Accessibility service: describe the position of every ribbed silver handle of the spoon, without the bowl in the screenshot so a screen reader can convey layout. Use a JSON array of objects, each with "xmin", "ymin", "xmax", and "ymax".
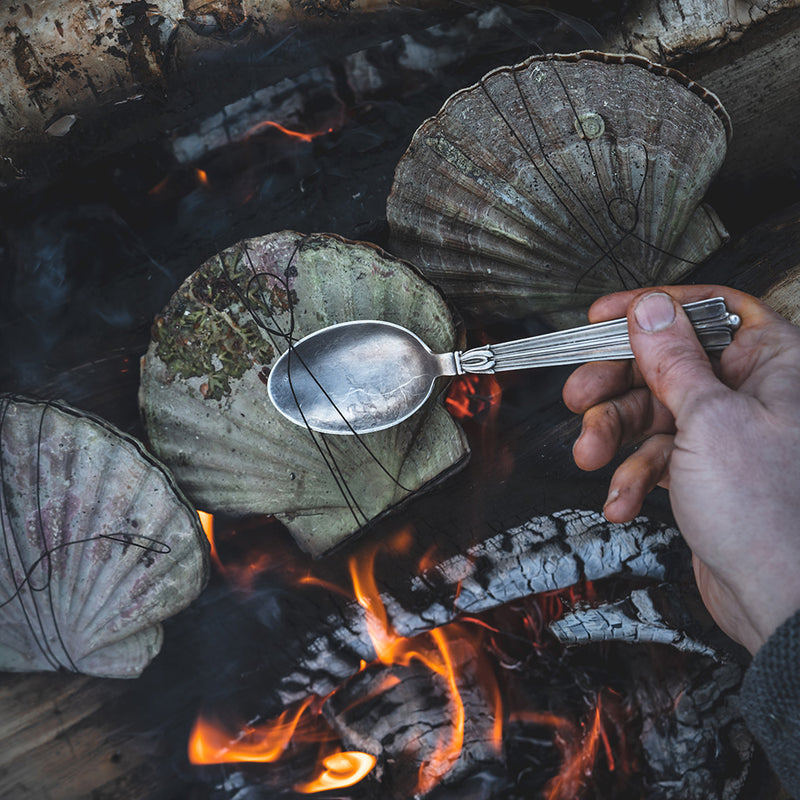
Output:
[{"xmin": 455, "ymin": 297, "xmax": 741, "ymax": 375}]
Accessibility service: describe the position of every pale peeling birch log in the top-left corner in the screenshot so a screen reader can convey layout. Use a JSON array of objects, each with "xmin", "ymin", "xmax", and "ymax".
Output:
[{"xmin": 0, "ymin": 0, "xmax": 454, "ymax": 171}]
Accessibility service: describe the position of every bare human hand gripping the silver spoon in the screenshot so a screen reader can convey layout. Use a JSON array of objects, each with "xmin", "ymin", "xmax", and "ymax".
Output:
[{"xmin": 563, "ymin": 286, "xmax": 800, "ymax": 653}]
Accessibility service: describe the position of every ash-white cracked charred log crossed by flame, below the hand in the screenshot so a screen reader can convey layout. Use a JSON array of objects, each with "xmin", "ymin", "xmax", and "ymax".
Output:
[{"xmin": 272, "ymin": 511, "xmax": 708, "ymax": 705}]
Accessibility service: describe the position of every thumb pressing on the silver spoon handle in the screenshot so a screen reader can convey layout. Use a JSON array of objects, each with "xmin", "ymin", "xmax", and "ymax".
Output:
[{"xmin": 628, "ymin": 292, "xmax": 726, "ymax": 420}]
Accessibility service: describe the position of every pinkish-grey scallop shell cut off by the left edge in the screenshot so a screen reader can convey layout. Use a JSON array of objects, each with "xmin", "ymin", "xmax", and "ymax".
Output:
[{"xmin": 0, "ymin": 395, "xmax": 209, "ymax": 678}]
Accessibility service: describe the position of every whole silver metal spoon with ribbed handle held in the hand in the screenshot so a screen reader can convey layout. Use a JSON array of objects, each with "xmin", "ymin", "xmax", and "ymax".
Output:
[{"xmin": 267, "ymin": 297, "xmax": 740, "ymax": 434}]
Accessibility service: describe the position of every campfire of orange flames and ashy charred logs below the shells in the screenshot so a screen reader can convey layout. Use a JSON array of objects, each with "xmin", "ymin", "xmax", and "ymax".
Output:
[{"xmin": 178, "ymin": 500, "xmax": 750, "ymax": 800}]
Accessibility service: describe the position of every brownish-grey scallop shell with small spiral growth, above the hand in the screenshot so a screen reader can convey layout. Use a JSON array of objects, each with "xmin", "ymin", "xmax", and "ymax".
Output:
[{"xmin": 387, "ymin": 51, "xmax": 730, "ymax": 316}]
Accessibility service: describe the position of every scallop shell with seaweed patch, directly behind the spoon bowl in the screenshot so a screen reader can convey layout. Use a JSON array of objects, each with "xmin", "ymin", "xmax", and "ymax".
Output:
[{"xmin": 139, "ymin": 232, "xmax": 468, "ymax": 555}]
